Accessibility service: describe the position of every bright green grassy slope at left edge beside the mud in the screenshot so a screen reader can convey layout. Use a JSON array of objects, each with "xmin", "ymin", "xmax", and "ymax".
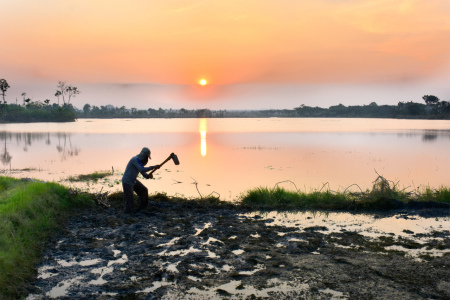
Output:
[{"xmin": 0, "ymin": 177, "xmax": 93, "ymax": 299}]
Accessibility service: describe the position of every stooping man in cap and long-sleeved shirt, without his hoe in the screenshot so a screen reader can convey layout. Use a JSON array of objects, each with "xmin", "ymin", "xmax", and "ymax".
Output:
[{"xmin": 122, "ymin": 147, "xmax": 160, "ymax": 214}]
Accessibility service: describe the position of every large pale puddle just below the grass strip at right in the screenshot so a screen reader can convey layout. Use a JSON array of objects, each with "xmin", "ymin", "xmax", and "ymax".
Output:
[{"xmin": 246, "ymin": 212, "xmax": 450, "ymax": 258}]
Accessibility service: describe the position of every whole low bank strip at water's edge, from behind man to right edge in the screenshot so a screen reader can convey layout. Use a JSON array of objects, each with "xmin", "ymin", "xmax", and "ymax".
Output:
[{"xmin": 103, "ymin": 172, "xmax": 450, "ymax": 212}]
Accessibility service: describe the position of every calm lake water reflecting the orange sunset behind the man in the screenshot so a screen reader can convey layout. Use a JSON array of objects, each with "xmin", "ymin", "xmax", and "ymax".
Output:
[{"xmin": 0, "ymin": 118, "xmax": 450, "ymax": 200}]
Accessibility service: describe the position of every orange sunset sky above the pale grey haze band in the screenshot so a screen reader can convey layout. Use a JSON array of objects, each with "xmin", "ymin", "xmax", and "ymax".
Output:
[{"xmin": 0, "ymin": 0, "xmax": 450, "ymax": 108}]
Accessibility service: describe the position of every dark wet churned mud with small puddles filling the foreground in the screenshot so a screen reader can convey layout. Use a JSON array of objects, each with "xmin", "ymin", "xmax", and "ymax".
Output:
[{"xmin": 28, "ymin": 202, "xmax": 450, "ymax": 299}]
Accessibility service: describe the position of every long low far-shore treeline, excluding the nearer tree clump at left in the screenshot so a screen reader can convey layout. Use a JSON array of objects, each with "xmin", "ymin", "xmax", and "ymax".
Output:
[{"xmin": 77, "ymin": 95, "xmax": 450, "ymax": 119}]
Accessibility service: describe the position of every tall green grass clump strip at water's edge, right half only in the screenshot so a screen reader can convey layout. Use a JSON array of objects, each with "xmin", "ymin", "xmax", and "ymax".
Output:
[{"xmin": 241, "ymin": 176, "xmax": 450, "ymax": 210}]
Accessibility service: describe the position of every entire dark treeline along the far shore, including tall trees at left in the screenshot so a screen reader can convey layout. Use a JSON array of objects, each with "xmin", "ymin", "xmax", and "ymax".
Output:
[{"xmin": 0, "ymin": 79, "xmax": 450, "ymax": 123}]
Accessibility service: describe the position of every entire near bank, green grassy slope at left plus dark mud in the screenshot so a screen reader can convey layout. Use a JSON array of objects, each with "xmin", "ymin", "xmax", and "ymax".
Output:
[{"xmin": 0, "ymin": 177, "xmax": 450, "ymax": 299}]
